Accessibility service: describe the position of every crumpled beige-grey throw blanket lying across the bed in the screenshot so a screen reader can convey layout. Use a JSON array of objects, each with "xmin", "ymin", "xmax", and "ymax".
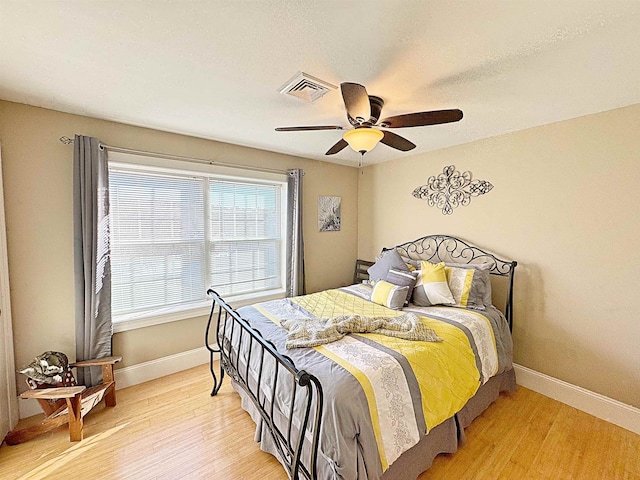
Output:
[{"xmin": 281, "ymin": 313, "xmax": 442, "ymax": 348}]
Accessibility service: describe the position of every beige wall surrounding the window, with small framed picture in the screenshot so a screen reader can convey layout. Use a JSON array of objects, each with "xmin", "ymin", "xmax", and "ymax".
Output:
[{"xmin": 0, "ymin": 101, "xmax": 358, "ymax": 372}]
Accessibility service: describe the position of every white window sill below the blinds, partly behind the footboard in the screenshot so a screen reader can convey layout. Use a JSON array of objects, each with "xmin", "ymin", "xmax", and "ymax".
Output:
[{"xmin": 113, "ymin": 290, "xmax": 285, "ymax": 333}]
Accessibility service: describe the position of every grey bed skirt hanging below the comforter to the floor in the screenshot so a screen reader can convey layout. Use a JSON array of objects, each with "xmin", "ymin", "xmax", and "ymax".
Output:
[{"xmin": 232, "ymin": 369, "xmax": 516, "ymax": 480}]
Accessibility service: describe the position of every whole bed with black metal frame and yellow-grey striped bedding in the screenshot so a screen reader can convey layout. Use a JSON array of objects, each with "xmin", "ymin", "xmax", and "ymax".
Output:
[{"xmin": 205, "ymin": 235, "xmax": 516, "ymax": 480}]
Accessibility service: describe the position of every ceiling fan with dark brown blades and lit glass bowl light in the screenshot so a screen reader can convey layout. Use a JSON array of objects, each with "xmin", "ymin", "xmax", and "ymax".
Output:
[{"xmin": 276, "ymin": 82, "xmax": 462, "ymax": 159}]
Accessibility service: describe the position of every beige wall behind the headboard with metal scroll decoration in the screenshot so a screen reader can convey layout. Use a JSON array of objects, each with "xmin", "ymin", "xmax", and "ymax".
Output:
[{"xmin": 358, "ymin": 105, "xmax": 640, "ymax": 407}]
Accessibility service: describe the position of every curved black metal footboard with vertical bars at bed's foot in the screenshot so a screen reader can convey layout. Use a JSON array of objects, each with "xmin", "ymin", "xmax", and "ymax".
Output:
[{"xmin": 205, "ymin": 289, "xmax": 323, "ymax": 480}]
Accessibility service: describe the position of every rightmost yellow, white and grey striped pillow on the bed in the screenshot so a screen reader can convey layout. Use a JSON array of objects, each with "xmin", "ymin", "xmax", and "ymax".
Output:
[{"xmin": 445, "ymin": 264, "xmax": 490, "ymax": 310}]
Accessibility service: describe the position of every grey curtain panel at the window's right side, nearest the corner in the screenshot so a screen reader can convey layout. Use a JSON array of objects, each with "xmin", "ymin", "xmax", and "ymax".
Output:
[{"xmin": 287, "ymin": 168, "xmax": 306, "ymax": 297}]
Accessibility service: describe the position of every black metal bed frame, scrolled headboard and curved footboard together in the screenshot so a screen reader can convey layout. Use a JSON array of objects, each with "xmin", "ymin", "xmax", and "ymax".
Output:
[{"xmin": 205, "ymin": 235, "xmax": 517, "ymax": 480}]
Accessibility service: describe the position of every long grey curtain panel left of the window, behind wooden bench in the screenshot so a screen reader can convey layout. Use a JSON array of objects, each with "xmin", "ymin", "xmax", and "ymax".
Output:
[{"xmin": 73, "ymin": 135, "xmax": 113, "ymax": 386}]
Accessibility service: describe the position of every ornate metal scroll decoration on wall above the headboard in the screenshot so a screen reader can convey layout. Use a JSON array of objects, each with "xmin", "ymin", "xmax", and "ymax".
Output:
[{"xmin": 413, "ymin": 165, "xmax": 493, "ymax": 215}]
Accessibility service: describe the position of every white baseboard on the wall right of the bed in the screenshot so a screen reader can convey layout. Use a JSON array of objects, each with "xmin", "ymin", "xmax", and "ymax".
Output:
[{"xmin": 513, "ymin": 364, "xmax": 640, "ymax": 435}]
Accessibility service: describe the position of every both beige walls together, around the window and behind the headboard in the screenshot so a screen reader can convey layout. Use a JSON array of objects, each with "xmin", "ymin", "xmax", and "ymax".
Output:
[{"xmin": 0, "ymin": 97, "xmax": 640, "ymax": 407}]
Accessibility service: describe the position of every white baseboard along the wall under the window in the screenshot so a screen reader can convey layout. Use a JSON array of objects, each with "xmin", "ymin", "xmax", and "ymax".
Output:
[{"xmin": 18, "ymin": 347, "xmax": 216, "ymax": 418}]
